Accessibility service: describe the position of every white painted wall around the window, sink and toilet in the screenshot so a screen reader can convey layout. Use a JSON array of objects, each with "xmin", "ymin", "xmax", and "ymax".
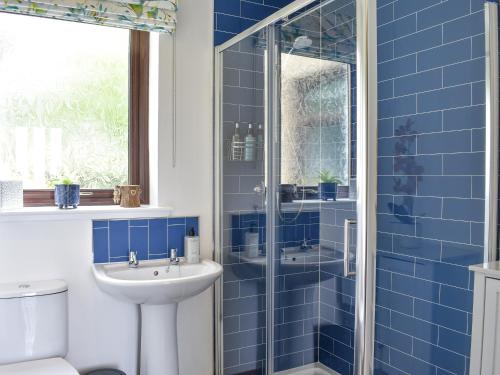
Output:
[{"xmin": 0, "ymin": 0, "xmax": 213, "ymax": 375}]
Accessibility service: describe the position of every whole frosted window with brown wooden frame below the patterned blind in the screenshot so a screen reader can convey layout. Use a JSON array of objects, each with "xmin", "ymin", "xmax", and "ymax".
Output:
[{"xmin": 0, "ymin": 13, "xmax": 149, "ymax": 206}]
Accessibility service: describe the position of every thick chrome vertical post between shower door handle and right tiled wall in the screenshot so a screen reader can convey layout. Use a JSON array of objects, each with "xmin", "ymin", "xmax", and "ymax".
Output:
[{"xmin": 354, "ymin": 0, "xmax": 377, "ymax": 375}]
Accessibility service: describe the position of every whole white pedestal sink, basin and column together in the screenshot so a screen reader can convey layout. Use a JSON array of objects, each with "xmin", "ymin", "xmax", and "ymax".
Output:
[{"xmin": 93, "ymin": 260, "xmax": 222, "ymax": 375}]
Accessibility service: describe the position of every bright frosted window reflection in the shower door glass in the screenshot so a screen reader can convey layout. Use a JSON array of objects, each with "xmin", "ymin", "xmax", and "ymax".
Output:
[{"xmin": 281, "ymin": 54, "xmax": 350, "ymax": 186}]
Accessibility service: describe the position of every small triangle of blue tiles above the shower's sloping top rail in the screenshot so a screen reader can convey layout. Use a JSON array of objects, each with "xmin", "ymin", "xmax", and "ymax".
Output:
[{"xmin": 214, "ymin": 0, "xmax": 293, "ymax": 45}]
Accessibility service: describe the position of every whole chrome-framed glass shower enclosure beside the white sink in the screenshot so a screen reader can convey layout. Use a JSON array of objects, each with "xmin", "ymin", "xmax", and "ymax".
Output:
[{"xmin": 215, "ymin": 0, "xmax": 377, "ymax": 375}]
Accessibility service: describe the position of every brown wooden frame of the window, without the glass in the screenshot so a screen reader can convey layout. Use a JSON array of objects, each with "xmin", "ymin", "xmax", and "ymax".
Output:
[{"xmin": 23, "ymin": 30, "xmax": 149, "ymax": 207}]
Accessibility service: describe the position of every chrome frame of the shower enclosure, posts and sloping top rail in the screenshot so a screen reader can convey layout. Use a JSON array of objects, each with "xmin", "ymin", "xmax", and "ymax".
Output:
[{"xmin": 213, "ymin": 0, "xmax": 378, "ymax": 375}]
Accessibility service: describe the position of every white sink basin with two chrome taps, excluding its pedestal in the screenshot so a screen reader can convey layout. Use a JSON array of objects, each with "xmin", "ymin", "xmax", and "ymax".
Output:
[{"xmin": 94, "ymin": 259, "xmax": 222, "ymax": 305}]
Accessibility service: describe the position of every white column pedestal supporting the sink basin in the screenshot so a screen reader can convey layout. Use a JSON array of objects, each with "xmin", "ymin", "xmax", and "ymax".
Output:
[{"xmin": 140, "ymin": 303, "xmax": 179, "ymax": 375}]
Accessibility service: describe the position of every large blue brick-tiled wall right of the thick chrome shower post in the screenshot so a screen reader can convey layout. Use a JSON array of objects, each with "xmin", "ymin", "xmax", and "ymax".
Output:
[{"xmin": 375, "ymin": 0, "xmax": 485, "ymax": 374}]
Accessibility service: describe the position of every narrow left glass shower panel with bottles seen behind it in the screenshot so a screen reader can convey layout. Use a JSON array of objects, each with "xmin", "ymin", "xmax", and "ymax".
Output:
[{"xmin": 219, "ymin": 30, "xmax": 268, "ymax": 375}]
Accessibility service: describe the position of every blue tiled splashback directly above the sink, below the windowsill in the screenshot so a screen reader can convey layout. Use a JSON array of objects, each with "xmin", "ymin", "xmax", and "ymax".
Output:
[{"xmin": 92, "ymin": 217, "xmax": 199, "ymax": 263}]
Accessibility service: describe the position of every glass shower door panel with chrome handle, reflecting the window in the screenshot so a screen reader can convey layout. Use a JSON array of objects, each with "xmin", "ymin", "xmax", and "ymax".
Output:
[{"xmin": 274, "ymin": 0, "xmax": 357, "ymax": 375}]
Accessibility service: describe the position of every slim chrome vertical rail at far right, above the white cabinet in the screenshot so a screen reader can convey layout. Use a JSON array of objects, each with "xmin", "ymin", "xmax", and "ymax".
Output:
[{"xmin": 484, "ymin": 2, "xmax": 499, "ymax": 262}]
